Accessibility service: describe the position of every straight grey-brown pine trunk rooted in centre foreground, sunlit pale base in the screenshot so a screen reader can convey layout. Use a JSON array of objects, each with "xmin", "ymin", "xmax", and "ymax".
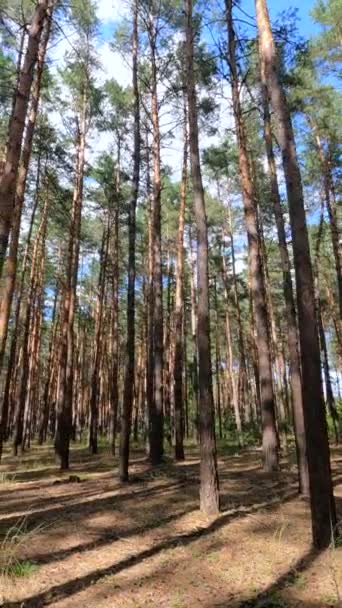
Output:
[{"xmin": 184, "ymin": 0, "xmax": 219, "ymax": 515}]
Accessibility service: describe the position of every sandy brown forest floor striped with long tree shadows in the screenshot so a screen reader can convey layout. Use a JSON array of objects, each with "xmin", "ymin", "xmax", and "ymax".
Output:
[{"xmin": 0, "ymin": 447, "xmax": 342, "ymax": 608}]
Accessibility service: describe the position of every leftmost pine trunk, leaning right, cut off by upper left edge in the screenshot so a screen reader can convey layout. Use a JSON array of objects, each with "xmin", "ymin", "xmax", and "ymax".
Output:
[{"xmin": 0, "ymin": 0, "xmax": 52, "ymax": 277}]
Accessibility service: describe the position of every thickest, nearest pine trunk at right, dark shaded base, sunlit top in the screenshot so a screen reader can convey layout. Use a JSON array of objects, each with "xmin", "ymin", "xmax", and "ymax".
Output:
[{"xmin": 255, "ymin": 0, "xmax": 337, "ymax": 548}]
